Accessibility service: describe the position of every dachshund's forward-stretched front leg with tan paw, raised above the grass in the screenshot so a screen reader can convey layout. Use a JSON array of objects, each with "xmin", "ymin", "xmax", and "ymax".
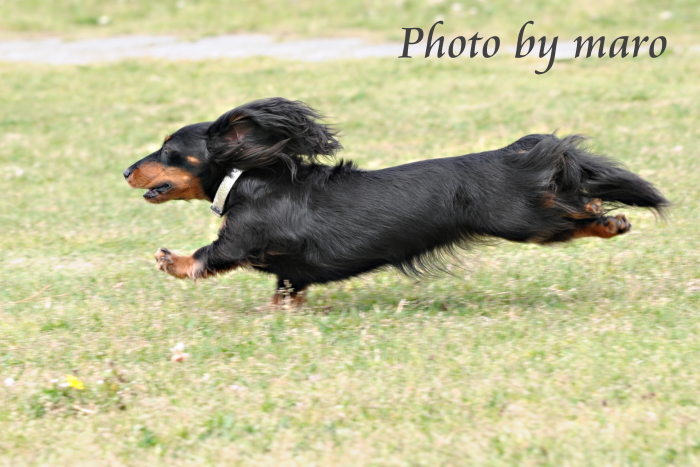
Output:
[{"xmin": 155, "ymin": 245, "xmax": 241, "ymax": 280}]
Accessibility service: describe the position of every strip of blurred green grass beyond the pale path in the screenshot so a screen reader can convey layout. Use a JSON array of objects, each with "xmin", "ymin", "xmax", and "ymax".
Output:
[{"xmin": 0, "ymin": 0, "xmax": 700, "ymax": 45}]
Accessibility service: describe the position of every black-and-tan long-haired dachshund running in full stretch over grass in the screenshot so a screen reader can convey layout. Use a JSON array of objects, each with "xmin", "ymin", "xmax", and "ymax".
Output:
[{"xmin": 124, "ymin": 97, "xmax": 668, "ymax": 304}]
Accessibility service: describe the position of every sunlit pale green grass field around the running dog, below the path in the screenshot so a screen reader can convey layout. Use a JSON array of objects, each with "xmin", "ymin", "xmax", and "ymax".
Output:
[{"xmin": 0, "ymin": 4, "xmax": 700, "ymax": 466}]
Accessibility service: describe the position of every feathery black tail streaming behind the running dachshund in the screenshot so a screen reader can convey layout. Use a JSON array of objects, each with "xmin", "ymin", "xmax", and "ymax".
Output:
[{"xmin": 511, "ymin": 135, "xmax": 670, "ymax": 215}]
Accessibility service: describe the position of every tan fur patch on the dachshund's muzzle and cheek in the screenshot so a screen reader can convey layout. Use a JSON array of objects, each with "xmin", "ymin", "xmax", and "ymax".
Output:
[{"xmin": 126, "ymin": 162, "xmax": 211, "ymax": 204}]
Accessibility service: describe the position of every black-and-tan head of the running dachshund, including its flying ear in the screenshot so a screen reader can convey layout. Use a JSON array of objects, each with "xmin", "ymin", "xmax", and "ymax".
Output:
[{"xmin": 124, "ymin": 97, "xmax": 341, "ymax": 203}]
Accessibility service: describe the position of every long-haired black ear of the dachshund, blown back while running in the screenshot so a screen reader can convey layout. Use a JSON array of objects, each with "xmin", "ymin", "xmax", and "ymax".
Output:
[{"xmin": 207, "ymin": 97, "xmax": 342, "ymax": 170}]
